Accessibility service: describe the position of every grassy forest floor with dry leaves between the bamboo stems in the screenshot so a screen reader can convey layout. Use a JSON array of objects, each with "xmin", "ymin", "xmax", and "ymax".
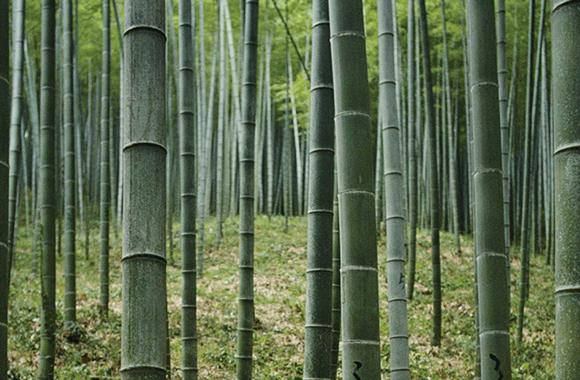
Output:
[{"xmin": 9, "ymin": 217, "xmax": 554, "ymax": 380}]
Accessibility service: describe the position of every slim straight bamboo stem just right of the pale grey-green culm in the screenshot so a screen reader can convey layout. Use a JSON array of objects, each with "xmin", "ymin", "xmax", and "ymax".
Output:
[{"xmin": 407, "ymin": 0, "xmax": 418, "ymax": 300}]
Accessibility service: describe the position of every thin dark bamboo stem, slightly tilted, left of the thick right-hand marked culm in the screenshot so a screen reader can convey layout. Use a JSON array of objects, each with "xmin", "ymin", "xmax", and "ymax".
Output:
[{"xmin": 419, "ymin": 0, "xmax": 441, "ymax": 346}]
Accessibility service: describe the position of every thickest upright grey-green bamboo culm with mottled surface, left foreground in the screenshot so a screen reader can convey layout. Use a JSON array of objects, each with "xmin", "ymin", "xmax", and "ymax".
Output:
[{"xmin": 121, "ymin": 0, "xmax": 167, "ymax": 380}]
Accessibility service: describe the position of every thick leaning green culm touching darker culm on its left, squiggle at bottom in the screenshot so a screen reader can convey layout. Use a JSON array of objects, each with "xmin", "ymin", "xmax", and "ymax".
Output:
[{"xmin": 329, "ymin": 0, "xmax": 380, "ymax": 380}]
